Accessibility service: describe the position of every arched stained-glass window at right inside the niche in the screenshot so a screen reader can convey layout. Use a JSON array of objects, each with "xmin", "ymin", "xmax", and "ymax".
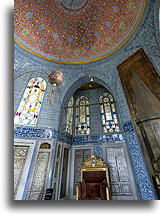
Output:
[{"xmin": 99, "ymin": 93, "xmax": 119, "ymax": 133}]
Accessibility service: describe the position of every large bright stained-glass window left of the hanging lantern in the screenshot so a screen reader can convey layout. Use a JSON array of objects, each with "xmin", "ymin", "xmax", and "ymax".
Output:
[{"xmin": 14, "ymin": 77, "xmax": 46, "ymax": 125}]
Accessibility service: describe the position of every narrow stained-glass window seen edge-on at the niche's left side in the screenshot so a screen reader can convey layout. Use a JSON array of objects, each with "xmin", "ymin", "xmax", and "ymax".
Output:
[{"xmin": 66, "ymin": 97, "xmax": 74, "ymax": 134}]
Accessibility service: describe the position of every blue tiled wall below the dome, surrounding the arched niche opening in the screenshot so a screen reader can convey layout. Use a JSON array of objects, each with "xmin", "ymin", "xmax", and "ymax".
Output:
[{"xmin": 14, "ymin": 0, "xmax": 160, "ymax": 200}]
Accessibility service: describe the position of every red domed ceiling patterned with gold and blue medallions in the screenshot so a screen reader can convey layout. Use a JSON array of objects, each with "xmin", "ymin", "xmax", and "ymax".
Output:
[{"xmin": 14, "ymin": 0, "xmax": 146, "ymax": 64}]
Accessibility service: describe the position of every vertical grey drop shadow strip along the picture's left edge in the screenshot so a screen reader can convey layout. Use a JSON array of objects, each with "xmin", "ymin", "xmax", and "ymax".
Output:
[{"xmin": 5, "ymin": 5, "xmax": 14, "ymax": 203}]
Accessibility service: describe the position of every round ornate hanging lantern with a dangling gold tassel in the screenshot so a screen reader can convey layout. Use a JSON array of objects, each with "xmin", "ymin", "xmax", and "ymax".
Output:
[{"xmin": 48, "ymin": 70, "xmax": 64, "ymax": 104}]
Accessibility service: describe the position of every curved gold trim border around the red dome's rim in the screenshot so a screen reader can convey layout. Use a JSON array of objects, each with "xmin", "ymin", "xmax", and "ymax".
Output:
[{"xmin": 14, "ymin": 0, "xmax": 147, "ymax": 64}]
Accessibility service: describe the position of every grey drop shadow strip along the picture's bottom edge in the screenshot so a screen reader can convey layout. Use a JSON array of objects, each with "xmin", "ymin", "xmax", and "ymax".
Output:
[{"xmin": 10, "ymin": 197, "xmax": 155, "ymax": 211}]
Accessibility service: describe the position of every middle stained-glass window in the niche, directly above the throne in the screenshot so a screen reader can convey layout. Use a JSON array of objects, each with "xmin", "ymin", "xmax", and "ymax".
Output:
[{"xmin": 76, "ymin": 96, "xmax": 90, "ymax": 135}]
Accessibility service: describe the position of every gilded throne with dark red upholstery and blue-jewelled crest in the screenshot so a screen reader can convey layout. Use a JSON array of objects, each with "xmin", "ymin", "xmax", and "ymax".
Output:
[{"xmin": 76, "ymin": 155, "xmax": 110, "ymax": 200}]
